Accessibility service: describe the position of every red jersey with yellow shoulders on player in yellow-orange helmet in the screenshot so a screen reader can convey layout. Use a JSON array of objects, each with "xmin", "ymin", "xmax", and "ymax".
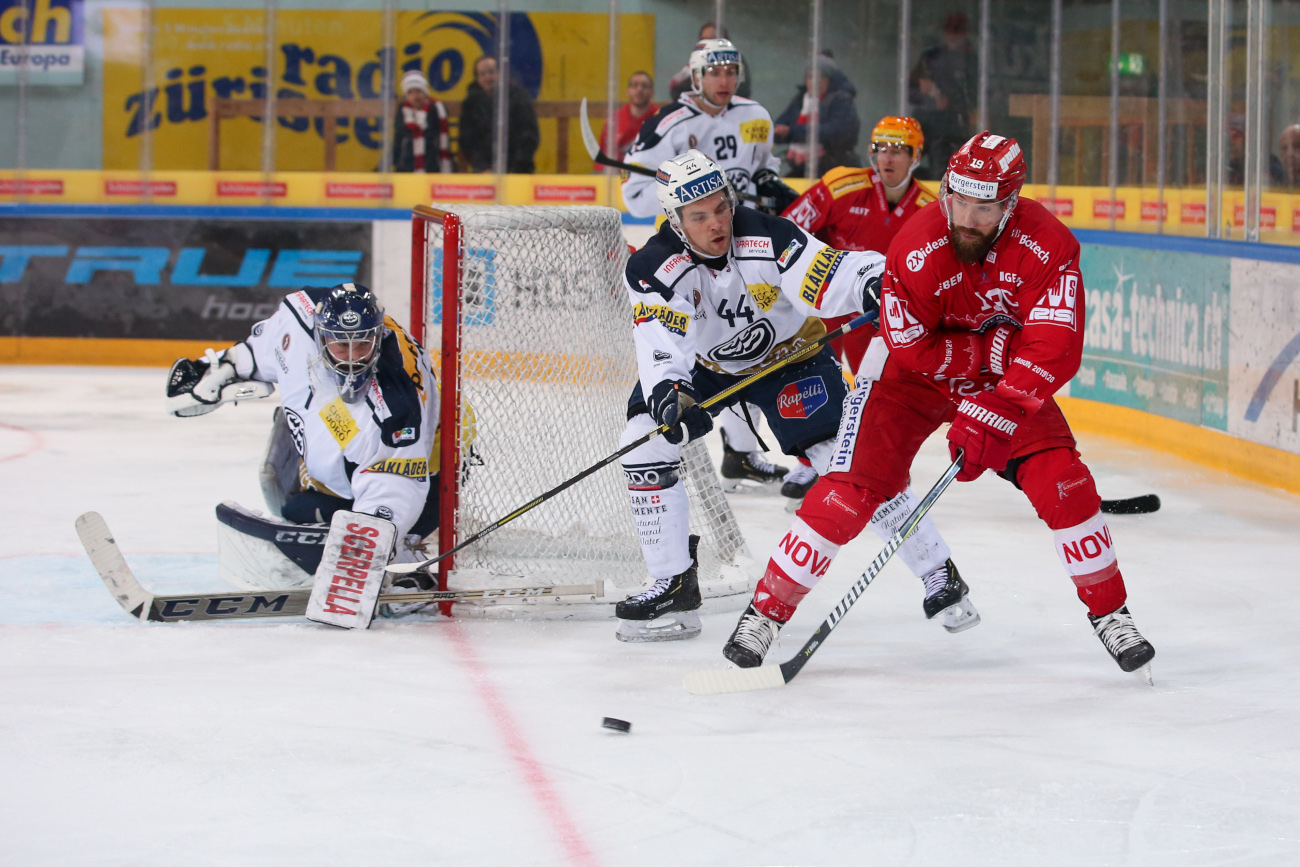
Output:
[{"xmin": 781, "ymin": 166, "xmax": 935, "ymax": 253}]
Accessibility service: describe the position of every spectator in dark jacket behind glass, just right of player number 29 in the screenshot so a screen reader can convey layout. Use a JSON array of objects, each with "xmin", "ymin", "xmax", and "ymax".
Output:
[{"xmin": 772, "ymin": 57, "xmax": 862, "ymax": 177}]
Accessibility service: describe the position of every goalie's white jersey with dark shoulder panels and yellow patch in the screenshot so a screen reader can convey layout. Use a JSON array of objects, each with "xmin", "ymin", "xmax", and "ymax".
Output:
[{"xmin": 226, "ymin": 289, "xmax": 438, "ymax": 534}]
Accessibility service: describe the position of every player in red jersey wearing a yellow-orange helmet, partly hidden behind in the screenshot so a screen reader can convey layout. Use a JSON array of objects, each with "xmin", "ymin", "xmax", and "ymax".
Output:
[{"xmin": 781, "ymin": 117, "xmax": 935, "ymax": 501}]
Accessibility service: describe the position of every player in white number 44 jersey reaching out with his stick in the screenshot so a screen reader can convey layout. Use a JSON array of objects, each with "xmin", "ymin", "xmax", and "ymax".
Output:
[{"xmin": 615, "ymin": 151, "xmax": 979, "ymax": 641}]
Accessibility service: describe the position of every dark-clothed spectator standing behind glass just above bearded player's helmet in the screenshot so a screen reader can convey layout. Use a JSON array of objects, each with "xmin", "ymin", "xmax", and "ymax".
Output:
[{"xmin": 907, "ymin": 12, "xmax": 979, "ymax": 181}]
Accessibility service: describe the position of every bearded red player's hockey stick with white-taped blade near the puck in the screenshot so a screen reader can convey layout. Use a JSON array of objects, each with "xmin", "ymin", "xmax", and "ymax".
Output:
[{"xmin": 681, "ymin": 451, "xmax": 962, "ymax": 695}]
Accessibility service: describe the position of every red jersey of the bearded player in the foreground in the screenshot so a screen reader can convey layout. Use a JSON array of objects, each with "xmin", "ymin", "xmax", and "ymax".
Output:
[{"xmin": 880, "ymin": 199, "xmax": 1084, "ymax": 415}]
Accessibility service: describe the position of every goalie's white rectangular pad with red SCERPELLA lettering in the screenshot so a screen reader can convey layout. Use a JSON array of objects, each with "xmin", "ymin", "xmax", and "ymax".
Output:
[{"xmin": 307, "ymin": 511, "xmax": 398, "ymax": 629}]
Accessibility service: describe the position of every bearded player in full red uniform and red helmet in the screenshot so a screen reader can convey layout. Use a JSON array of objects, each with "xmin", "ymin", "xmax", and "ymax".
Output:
[{"xmin": 723, "ymin": 131, "xmax": 1156, "ymax": 671}]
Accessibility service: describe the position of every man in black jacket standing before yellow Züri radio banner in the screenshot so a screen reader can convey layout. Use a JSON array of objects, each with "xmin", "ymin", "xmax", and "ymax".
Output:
[{"xmin": 460, "ymin": 56, "xmax": 542, "ymax": 174}]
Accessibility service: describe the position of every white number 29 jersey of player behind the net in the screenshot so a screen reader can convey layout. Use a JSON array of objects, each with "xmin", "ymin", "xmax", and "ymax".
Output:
[{"xmin": 623, "ymin": 94, "xmax": 781, "ymax": 217}]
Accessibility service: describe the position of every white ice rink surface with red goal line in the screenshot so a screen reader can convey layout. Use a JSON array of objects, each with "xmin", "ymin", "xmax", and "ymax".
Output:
[{"xmin": 0, "ymin": 367, "xmax": 1300, "ymax": 867}]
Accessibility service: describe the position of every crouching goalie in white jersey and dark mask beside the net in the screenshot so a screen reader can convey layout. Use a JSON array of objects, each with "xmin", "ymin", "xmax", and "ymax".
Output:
[{"xmin": 166, "ymin": 283, "xmax": 438, "ymax": 608}]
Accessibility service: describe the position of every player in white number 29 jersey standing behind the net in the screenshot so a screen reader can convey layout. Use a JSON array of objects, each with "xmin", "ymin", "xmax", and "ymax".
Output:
[{"xmin": 623, "ymin": 39, "xmax": 798, "ymax": 491}]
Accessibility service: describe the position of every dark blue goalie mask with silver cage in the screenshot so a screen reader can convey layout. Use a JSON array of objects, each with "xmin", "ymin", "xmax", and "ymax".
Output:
[{"xmin": 316, "ymin": 283, "xmax": 384, "ymax": 403}]
